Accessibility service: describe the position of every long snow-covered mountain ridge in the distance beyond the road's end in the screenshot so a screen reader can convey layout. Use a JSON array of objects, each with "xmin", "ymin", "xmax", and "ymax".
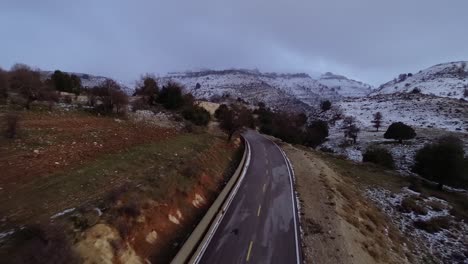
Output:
[{"xmin": 160, "ymin": 69, "xmax": 371, "ymax": 111}]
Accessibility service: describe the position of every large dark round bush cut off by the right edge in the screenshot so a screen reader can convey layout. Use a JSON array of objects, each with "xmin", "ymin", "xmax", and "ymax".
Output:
[{"xmin": 413, "ymin": 136, "xmax": 468, "ymax": 188}]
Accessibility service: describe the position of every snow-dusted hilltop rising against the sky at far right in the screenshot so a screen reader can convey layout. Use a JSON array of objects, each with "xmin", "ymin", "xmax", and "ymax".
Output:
[{"xmin": 372, "ymin": 61, "xmax": 468, "ymax": 98}]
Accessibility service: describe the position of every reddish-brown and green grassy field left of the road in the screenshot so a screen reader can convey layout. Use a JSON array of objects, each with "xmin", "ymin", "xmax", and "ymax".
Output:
[{"xmin": 0, "ymin": 106, "xmax": 239, "ymax": 260}]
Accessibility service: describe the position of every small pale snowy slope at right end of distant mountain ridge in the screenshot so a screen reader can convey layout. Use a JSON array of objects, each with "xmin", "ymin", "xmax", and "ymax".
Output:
[{"xmin": 318, "ymin": 72, "xmax": 373, "ymax": 97}]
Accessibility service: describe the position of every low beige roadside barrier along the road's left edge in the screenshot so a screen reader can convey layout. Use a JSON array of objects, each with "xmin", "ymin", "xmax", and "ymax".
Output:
[{"xmin": 171, "ymin": 137, "xmax": 250, "ymax": 264}]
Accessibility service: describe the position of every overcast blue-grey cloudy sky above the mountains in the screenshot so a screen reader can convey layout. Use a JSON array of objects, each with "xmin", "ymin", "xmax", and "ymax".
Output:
[{"xmin": 0, "ymin": 0, "xmax": 468, "ymax": 85}]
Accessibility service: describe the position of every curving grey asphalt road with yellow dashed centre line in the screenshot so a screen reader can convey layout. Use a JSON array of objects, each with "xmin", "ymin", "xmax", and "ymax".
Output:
[{"xmin": 196, "ymin": 131, "xmax": 302, "ymax": 264}]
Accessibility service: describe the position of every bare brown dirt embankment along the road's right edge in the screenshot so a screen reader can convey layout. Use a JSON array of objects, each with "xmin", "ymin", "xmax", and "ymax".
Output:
[{"xmin": 283, "ymin": 144, "xmax": 411, "ymax": 264}]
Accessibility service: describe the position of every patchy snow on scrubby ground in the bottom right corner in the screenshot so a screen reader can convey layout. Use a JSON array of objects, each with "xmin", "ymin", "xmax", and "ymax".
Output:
[{"xmin": 366, "ymin": 188, "xmax": 468, "ymax": 264}]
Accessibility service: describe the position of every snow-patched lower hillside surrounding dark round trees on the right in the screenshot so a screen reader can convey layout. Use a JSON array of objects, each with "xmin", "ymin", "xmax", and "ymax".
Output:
[{"xmin": 323, "ymin": 94, "xmax": 468, "ymax": 173}]
